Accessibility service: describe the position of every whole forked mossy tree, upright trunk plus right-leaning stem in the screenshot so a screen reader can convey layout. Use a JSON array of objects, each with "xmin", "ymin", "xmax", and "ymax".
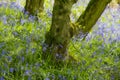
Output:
[{"xmin": 43, "ymin": 0, "xmax": 111, "ymax": 62}]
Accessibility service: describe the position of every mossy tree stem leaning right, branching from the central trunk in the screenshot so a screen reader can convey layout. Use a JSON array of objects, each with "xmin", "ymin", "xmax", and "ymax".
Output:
[{"xmin": 73, "ymin": 0, "xmax": 111, "ymax": 38}]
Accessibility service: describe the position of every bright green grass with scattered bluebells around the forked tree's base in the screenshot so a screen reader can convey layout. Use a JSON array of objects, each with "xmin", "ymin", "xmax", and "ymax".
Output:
[{"xmin": 0, "ymin": 0, "xmax": 120, "ymax": 80}]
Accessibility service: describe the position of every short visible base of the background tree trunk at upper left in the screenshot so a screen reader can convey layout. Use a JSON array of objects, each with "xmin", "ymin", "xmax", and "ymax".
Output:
[{"xmin": 25, "ymin": 0, "xmax": 44, "ymax": 15}]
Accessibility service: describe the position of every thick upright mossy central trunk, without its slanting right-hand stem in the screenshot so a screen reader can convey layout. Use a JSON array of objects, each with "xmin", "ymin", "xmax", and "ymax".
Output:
[{"xmin": 43, "ymin": 0, "xmax": 76, "ymax": 62}]
